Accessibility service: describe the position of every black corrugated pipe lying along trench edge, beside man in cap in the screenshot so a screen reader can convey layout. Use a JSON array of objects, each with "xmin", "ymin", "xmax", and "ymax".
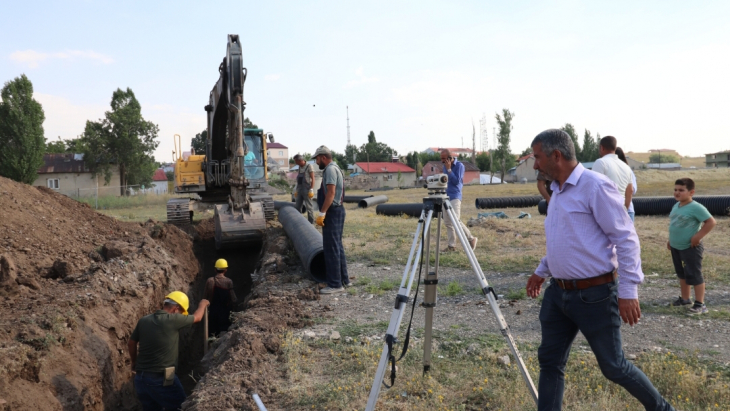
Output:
[{"xmin": 279, "ymin": 206, "xmax": 327, "ymax": 283}]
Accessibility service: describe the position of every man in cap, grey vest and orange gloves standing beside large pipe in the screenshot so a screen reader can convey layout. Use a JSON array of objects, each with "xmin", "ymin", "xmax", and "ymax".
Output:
[{"xmin": 312, "ymin": 146, "xmax": 350, "ymax": 294}]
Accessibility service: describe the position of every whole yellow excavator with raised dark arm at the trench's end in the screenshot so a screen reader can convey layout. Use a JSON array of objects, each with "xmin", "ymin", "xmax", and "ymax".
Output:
[{"xmin": 167, "ymin": 34, "xmax": 274, "ymax": 249}]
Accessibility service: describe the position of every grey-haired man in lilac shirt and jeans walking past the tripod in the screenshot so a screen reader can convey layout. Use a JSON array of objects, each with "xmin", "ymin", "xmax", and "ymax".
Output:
[{"xmin": 527, "ymin": 129, "xmax": 674, "ymax": 411}]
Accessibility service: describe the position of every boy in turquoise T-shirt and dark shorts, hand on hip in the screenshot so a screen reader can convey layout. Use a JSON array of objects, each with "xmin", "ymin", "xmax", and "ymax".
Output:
[{"xmin": 667, "ymin": 178, "xmax": 715, "ymax": 315}]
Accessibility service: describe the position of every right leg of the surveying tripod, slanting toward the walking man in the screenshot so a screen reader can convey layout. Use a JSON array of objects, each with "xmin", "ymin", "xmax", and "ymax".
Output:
[{"xmin": 444, "ymin": 200, "xmax": 537, "ymax": 404}]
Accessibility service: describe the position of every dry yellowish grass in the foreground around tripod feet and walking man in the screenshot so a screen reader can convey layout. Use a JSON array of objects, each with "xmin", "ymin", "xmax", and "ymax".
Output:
[{"xmin": 277, "ymin": 332, "xmax": 730, "ymax": 410}]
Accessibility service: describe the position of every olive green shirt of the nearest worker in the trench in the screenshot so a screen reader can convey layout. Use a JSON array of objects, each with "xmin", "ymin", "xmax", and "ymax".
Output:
[{"xmin": 130, "ymin": 310, "xmax": 195, "ymax": 372}]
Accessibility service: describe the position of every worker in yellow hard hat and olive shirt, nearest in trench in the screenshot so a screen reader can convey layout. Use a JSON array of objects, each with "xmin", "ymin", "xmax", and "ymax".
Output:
[{"xmin": 127, "ymin": 291, "xmax": 210, "ymax": 411}]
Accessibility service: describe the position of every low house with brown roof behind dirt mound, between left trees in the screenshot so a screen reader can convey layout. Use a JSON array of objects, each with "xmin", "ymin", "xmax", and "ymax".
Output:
[{"xmin": 33, "ymin": 153, "xmax": 121, "ymax": 198}]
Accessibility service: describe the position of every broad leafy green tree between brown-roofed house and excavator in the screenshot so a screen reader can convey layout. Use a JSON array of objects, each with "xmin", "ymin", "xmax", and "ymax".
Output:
[{"xmin": 81, "ymin": 88, "xmax": 159, "ymax": 195}]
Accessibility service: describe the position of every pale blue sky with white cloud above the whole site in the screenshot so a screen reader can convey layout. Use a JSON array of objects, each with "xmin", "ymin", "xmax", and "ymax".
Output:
[{"xmin": 0, "ymin": 0, "xmax": 730, "ymax": 162}]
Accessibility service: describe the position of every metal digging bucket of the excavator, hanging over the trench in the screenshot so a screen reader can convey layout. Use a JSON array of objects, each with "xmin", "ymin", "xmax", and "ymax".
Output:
[{"xmin": 215, "ymin": 202, "xmax": 266, "ymax": 250}]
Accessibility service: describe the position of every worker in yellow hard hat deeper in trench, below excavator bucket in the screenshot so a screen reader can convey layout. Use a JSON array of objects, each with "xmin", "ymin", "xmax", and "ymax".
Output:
[{"xmin": 205, "ymin": 258, "xmax": 237, "ymax": 335}]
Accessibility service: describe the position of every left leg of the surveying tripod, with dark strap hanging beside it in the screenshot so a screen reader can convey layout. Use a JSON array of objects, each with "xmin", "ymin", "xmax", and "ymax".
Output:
[{"xmin": 365, "ymin": 210, "xmax": 433, "ymax": 411}]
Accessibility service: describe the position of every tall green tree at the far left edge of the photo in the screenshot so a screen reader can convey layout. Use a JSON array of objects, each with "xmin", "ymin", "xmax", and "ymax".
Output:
[{"xmin": 0, "ymin": 74, "xmax": 46, "ymax": 184}]
